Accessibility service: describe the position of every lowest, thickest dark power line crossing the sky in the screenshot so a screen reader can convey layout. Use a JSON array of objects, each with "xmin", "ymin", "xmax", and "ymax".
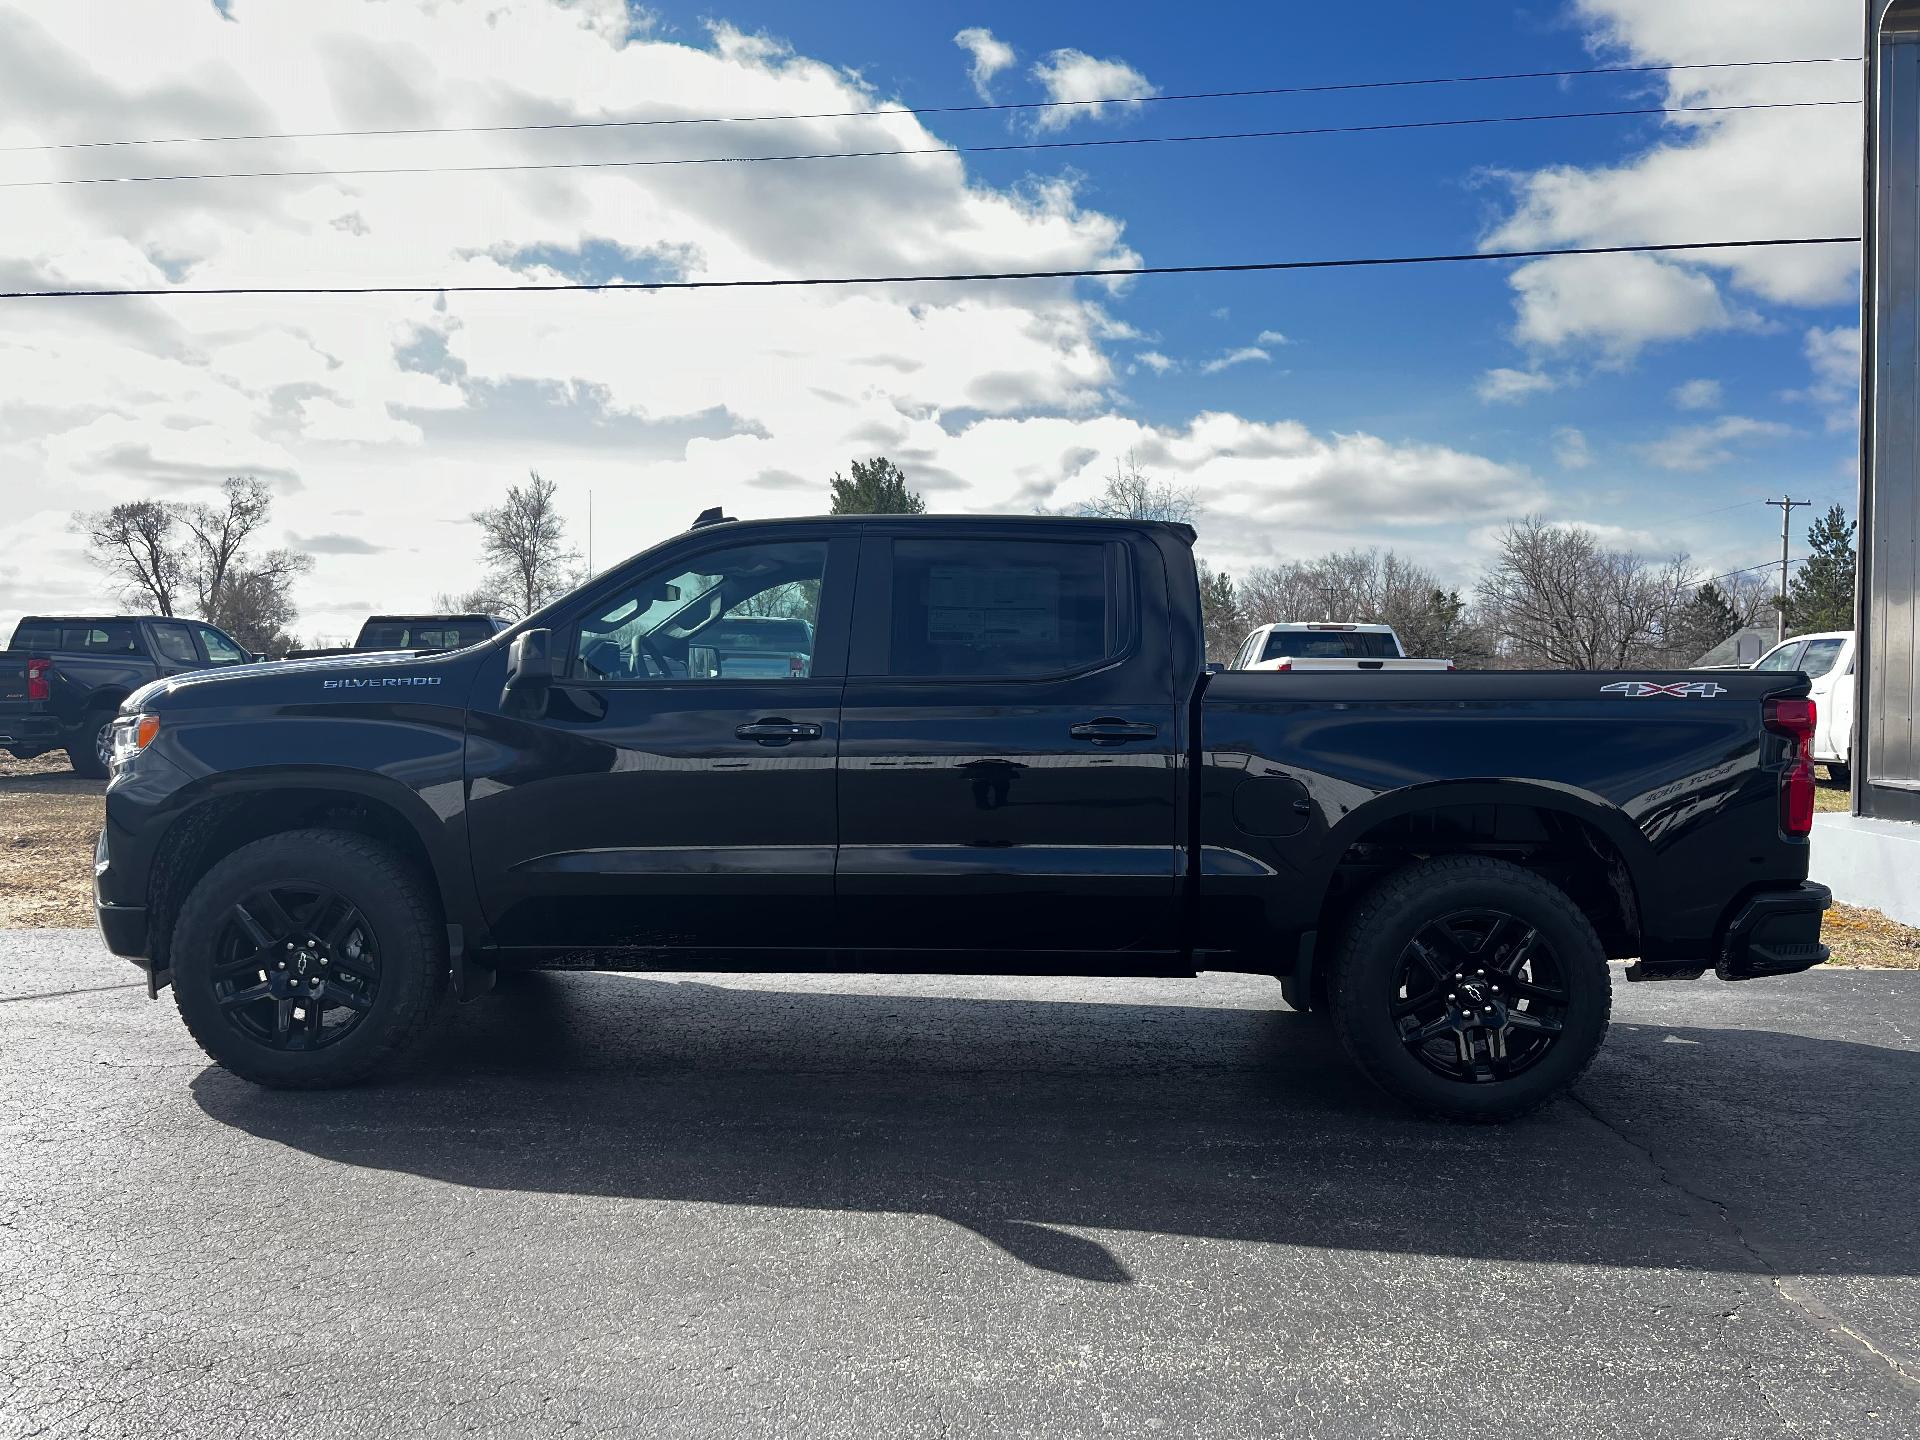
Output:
[{"xmin": 0, "ymin": 234, "xmax": 1860, "ymax": 300}]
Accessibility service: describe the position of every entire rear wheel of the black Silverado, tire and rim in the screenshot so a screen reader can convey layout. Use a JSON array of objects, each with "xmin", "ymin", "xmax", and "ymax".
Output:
[{"xmin": 1332, "ymin": 856, "xmax": 1613, "ymax": 1121}]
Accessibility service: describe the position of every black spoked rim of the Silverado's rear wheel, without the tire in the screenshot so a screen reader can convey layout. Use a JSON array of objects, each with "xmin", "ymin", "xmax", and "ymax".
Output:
[{"xmin": 1388, "ymin": 910, "xmax": 1569, "ymax": 1085}]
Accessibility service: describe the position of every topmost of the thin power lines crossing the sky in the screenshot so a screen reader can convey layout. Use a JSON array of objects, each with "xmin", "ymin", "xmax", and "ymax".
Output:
[{"xmin": 0, "ymin": 56, "xmax": 1860, "ymax": 154}]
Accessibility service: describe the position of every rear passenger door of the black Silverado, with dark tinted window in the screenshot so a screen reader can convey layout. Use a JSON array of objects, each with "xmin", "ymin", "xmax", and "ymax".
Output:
[{"xmin": 837, "ymin": 522, "xmax": 1181, "ymax": 972}]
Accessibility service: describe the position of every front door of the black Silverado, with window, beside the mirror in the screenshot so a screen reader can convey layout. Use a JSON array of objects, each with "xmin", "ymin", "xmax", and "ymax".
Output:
[{"xmin": 467, "ymin": 526, "xmax": 856, "ymax": 968}]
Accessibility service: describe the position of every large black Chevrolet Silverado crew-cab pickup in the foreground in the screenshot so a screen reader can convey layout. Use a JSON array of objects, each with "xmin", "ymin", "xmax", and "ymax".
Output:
[{"xmin": 96, "ymin": 513, "xmax": 1830, "ymax": 1119}]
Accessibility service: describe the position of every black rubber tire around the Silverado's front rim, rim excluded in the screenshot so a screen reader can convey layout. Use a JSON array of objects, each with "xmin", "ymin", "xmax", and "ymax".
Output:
[{"xmin": 171, "ymin": 829, "xmax": 447, "ymax": 1091}]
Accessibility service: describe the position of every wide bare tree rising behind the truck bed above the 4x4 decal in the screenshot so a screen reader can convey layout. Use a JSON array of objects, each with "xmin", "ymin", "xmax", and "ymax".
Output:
[{"xmin": 1478, "ymin": 516, "xmax": 1697, "ymax": 670}]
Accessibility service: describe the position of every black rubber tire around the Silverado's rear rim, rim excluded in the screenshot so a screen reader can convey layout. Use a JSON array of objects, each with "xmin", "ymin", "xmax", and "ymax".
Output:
[{"xmin": 1329, "ymin": 854, "xmax": 1613, "ymax": 1123}]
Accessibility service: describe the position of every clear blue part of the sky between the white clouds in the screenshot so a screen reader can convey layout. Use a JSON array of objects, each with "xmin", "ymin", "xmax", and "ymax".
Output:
[{"xmin": 706, "ymin": 0, "xmax": 1859, "ymax": 545}]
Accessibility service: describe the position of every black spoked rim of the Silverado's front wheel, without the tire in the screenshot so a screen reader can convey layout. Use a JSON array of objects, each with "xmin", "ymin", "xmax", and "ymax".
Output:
[{"xmin": 213, "ymin": 881, "xmax": 380, "ymax": 1050}]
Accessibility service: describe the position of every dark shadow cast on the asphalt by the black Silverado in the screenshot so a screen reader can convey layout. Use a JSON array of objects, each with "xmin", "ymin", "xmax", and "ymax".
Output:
[{"xmin": 194, "ymin": 973, "xmax": 1920, "ymax": 1284}]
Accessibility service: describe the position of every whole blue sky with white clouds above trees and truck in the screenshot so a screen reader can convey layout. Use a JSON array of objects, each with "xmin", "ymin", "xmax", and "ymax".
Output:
[{"xmin": 0, "ymin": 0, "xmax": 1859, "ymax": 634}]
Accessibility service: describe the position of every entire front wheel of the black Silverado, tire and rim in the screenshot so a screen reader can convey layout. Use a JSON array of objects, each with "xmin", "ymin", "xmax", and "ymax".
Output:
[{"xmin": 171, "ymin": 829, "xmax": 447, "ymax": 1089}]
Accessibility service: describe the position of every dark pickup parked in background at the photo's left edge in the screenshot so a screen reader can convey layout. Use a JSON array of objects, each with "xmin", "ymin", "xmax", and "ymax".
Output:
[{"xmin": 0, "ymin": 614, "xmax": 257, "ymax": 780}]
